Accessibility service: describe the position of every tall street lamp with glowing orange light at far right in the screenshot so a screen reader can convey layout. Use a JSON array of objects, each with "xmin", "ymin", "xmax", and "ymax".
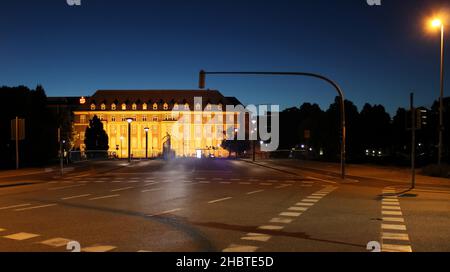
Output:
[{"xmin": 431, "ymin": 18, "xmax": 445, "ymax": 165}]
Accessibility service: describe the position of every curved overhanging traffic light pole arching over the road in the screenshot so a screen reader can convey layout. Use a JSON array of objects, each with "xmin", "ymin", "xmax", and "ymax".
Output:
[{"xmin": 199, "ymin": 70, "xmax": 346, "ymax": 179}]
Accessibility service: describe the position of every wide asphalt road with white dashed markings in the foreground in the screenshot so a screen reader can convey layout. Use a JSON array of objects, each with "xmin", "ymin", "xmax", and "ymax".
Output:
[{"xmin": 0, "ymin": 159, "xmax": 450, "ymax": 252}]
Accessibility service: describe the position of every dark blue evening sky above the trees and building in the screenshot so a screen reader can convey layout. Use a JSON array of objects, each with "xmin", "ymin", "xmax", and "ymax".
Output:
[{"xmin": 0, "ymin": 0, "xmax": 450, "ymax": 113}]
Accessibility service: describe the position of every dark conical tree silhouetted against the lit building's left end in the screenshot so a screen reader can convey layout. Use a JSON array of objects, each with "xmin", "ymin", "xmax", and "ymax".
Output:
[{"xmin": 84, "ymin": 115, "xmax": 109, "ymax": 156}]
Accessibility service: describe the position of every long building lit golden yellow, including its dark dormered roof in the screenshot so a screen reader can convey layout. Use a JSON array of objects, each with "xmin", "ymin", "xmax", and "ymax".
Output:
[{"xmin": 73, "ymin": 90, "xmax": 241, "ymax": 158}]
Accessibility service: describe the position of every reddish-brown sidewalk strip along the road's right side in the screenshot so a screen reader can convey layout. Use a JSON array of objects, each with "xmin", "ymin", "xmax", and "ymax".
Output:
[{"xmin": 246, "ymin": 159, "xmax": 450, "ymax": 185}]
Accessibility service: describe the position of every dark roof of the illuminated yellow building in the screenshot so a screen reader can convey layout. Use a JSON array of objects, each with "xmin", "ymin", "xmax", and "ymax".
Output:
[{"xmin": 81, "ymin": 90, "xmax": 240, "ymax": 109}]
